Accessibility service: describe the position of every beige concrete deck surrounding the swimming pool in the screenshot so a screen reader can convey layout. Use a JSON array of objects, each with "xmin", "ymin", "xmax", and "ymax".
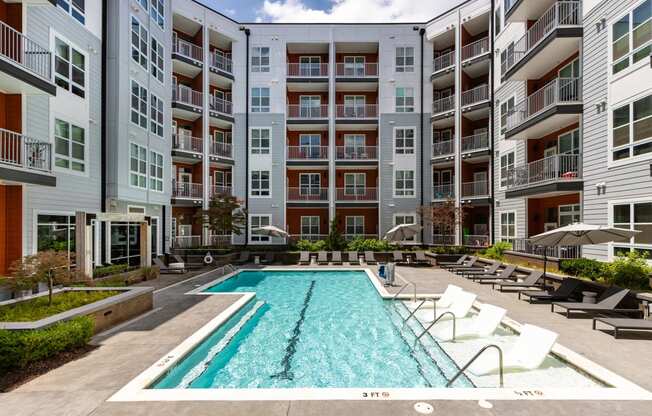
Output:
[{"xmin": 0, "ymin": 266, "xmax": 652, "ymax": 416}]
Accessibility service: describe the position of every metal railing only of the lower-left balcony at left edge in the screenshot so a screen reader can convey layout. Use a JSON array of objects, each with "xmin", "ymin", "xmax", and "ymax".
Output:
[{"xmin": 0, "ymin": 129, "xmax": 52, "ymax": 172}]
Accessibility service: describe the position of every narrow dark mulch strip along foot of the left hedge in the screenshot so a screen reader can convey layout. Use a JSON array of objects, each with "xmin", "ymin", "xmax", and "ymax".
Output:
[{"xmin": 0, "ymin": 345, "xmax": 97, "ymax": 393}]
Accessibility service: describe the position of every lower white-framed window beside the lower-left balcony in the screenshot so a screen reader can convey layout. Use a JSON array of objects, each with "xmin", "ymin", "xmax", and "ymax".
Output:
[{"xmin": 54, "ymin": 119, "xmax": 86, "ymax": 172}]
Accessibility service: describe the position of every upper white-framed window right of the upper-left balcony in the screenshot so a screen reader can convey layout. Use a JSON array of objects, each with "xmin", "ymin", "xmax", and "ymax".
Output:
[{"xmin": 54, "ymin": 38, "xmax": 86, "ymax": 98}]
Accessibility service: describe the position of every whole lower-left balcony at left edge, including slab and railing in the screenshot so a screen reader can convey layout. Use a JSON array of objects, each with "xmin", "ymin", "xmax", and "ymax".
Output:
[{"xmin": 0, "ymin": 129, "xmax": 56, "ymax": 186}]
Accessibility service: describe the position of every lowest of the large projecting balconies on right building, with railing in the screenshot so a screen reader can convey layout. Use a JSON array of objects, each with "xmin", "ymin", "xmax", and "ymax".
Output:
[{"xmin": 505, "ymin": 154, "xmax": 583, "ymax": 198}]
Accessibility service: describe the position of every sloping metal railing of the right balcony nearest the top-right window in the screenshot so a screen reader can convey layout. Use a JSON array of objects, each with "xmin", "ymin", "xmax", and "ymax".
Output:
[{"xmin": 501, "ymin": 1, "xmax": 582, "ymax": 75}]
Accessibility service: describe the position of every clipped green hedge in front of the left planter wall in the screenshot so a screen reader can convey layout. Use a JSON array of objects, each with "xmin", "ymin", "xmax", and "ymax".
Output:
[{"xmin": 0, "ymin": 316, "xmax": 93, "ymax": 371}]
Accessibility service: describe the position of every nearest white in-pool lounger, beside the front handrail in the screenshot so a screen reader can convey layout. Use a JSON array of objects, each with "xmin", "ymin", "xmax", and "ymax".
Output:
[{"xmin": 469, "ymin": 324, "xmax": 558, "ymax": 376}]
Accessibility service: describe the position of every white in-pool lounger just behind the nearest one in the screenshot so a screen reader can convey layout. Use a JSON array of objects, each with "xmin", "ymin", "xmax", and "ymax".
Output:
[{"xmin": 430, "ymin": 303, "xmax": 507, "ymax": 341}]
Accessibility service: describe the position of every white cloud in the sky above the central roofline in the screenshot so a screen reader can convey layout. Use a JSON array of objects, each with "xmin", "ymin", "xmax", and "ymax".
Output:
[{"xmin": 258, "ymin": 0, "xmax": 462, "ymax": 23}]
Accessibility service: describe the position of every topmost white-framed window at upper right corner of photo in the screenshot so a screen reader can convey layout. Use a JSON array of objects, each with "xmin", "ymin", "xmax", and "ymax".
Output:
[{"xmin": 611, "ymin": 0, "xmax": 652, "ymax": 74}]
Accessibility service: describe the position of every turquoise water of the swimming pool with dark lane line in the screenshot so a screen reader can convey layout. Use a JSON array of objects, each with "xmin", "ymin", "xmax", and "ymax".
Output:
[{"xmin": 151, "ymin": 271, "xmax": 473, "ymax": 389}]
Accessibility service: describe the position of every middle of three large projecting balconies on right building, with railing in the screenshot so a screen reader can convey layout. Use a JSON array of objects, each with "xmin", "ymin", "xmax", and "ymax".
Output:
[{"xmin": 502, "ymin": 78, "xmax": 583, "ymax": 139}]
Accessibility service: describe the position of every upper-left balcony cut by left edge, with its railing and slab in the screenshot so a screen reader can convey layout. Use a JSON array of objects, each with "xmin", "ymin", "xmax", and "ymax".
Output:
[{"xmin": 0, "ymin": 22, "xmax": 57, "ymax": 95}]
